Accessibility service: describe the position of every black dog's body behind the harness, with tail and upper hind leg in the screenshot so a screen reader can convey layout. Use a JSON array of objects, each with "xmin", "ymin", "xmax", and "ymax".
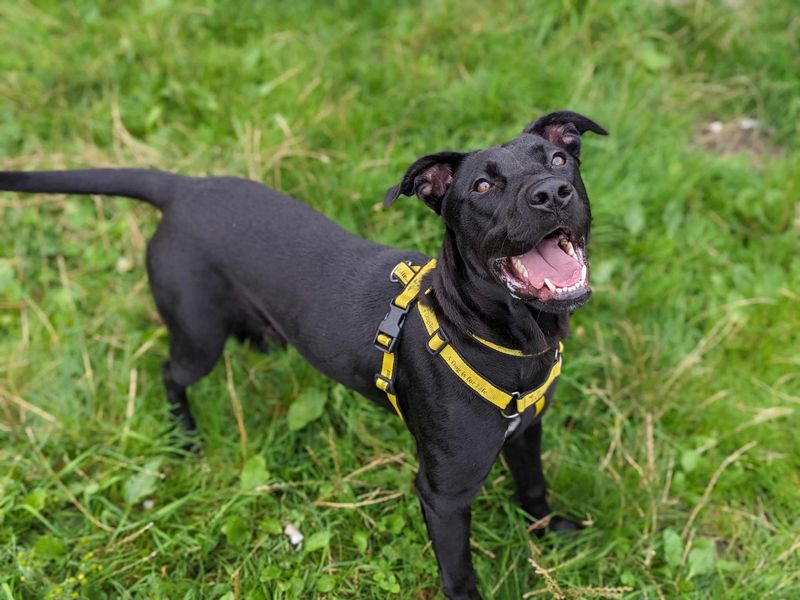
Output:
[{"xmin": 0, "ymin": 169, "xmax": 419, "ymax": 412}]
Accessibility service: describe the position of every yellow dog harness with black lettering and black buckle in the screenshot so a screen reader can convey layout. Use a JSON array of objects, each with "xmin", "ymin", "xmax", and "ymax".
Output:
[{"xmin": 374, "ymin": 259, "xmax": 564, "ymax": 419}]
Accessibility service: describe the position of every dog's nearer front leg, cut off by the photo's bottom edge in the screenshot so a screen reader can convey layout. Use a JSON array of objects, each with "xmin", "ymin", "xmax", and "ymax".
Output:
[{"xmin": 415, "ymin": 467, "xmax": 482, "ymax": 600}]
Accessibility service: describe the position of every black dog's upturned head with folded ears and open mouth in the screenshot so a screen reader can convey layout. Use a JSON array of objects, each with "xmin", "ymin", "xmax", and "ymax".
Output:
[{"xmin": 384, "ymin": 111, "xmax": 607, "ymax": 313}]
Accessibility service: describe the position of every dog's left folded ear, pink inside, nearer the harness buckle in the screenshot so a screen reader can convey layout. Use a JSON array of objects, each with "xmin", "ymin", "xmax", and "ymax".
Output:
[{"xmin": 383, "ymin": 152, "xmax": 467, "ymax": 215}]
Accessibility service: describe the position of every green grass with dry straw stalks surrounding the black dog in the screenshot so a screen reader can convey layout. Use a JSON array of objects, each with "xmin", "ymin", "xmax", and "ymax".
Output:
[{"xmin": 0, "ymin": 0, "xmax": 800, "ymax": 600}]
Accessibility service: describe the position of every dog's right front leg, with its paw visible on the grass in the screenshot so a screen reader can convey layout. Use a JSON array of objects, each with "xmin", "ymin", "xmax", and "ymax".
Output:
[{"xmin": 503, "ymin": 420, "xmax": 580, "ymax": 535}]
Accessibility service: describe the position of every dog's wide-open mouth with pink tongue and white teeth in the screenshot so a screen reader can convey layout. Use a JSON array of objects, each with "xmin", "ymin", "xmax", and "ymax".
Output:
[{"xmin": 496, "ymin": 229, "xmax": 591, "ymax": 304}]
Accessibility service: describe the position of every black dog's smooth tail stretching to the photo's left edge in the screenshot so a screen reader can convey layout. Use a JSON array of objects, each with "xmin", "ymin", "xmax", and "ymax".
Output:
[{"xmin": 0, "ymin": 169, "xmax": 183, "ymax": 210}]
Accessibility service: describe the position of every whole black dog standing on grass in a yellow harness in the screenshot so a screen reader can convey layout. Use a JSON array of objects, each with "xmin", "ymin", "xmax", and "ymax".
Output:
[{"xmin": 0, "ymin": 111, "xmax": 606, "ymax": 598}]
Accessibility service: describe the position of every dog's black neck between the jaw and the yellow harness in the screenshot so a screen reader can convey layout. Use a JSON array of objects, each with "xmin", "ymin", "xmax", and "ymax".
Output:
[{"xmin": 433, "ymin": 228, "xmax": 569, "ymax": 354}]
